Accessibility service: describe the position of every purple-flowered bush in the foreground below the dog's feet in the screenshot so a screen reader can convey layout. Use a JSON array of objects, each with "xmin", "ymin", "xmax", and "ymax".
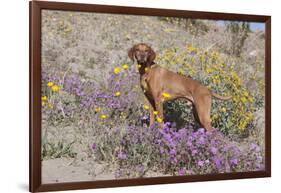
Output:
[{"xmin": 94, "ymin": 123, "xmax": 264, "ymax": 177}]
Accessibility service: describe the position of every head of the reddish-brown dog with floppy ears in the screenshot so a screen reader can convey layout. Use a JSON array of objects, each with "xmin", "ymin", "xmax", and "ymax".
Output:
[{"xmin": 128, "ymin": 43, "xmax": 156, "ymax": 65}]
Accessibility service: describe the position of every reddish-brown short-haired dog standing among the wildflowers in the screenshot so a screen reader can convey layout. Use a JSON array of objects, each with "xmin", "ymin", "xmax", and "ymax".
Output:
[{"xmin": 128, "ymin": 43, "xmax": 232, "ymax": 131}]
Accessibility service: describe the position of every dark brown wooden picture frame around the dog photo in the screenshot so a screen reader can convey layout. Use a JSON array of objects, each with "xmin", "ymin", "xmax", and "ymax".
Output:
[{"xmin": 29, "ymin": 1, "xmax": 271, "ymax": 192}]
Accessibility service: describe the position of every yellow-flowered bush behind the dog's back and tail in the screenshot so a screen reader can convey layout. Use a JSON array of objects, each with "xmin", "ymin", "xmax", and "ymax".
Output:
[{"xmin": 157, "ymin": 44, "xmax": 264, "ymax": 134}]
